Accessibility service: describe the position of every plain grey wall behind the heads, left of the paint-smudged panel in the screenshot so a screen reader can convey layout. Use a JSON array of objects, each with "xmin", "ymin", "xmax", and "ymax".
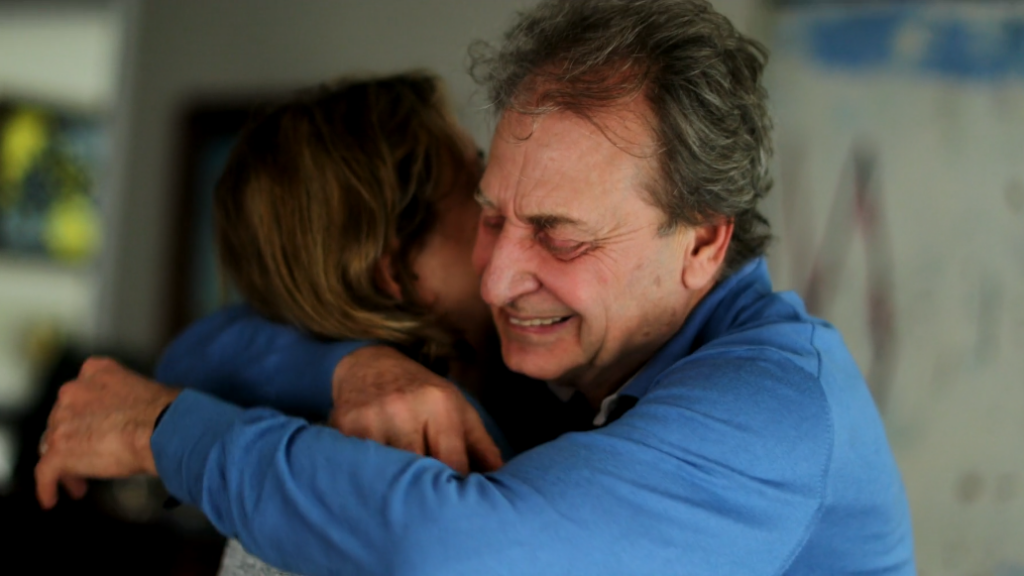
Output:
[{"xmin": 100, "ymin": 0, "xmax": 762, "ymax": 353}]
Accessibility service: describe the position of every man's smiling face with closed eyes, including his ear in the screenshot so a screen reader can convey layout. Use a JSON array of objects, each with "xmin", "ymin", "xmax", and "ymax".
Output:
[{"xmin": 473, "ymin": 107, "xmax": 694, "ymax": 402}]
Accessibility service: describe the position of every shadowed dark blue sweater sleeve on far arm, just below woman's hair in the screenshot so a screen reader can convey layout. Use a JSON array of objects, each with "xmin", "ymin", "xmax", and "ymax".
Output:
[{"xmin": 156, "ymin": 304, "xmax": 373, "ymax": 419}]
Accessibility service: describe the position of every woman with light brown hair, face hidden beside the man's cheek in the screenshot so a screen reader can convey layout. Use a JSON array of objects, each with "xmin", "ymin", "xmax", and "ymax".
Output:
[{"xmin": 158, "ymin": 73, "xmax": 497, "ymax": 574}]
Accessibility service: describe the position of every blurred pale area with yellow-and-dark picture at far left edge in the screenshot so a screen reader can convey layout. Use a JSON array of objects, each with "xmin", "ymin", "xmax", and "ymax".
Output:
[{"xmin": 0, "ymin": 2, "xmax": 126, "ymax": 487}]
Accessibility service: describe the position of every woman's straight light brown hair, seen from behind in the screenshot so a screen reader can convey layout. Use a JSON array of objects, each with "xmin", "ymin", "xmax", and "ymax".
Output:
[{"xmin": 214, "ymin": 73, "xmax": 480, "ymax": 358}]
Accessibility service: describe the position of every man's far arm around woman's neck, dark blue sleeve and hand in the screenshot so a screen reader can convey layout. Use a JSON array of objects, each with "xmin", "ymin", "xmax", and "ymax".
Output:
[{"xmin": 156, "ymin": 305, "xmax": 503, "ymax": 471}]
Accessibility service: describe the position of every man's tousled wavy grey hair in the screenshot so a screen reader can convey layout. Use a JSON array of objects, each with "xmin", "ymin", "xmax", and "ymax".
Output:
[{"xmin": 470, "ymin": 0, "xmax": 772, "ymax": 276}]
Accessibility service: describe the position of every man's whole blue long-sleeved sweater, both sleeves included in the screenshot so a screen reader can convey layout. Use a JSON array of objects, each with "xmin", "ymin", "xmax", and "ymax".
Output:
[{"xmin": 152, "ymin": 260, "xmax": 915, "ymax": 576}]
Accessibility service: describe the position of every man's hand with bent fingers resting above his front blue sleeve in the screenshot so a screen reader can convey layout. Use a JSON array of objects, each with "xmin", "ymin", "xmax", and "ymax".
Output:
[{"xmin": 330, "ymin": 345, "xmax": 502, "ymax": 475}]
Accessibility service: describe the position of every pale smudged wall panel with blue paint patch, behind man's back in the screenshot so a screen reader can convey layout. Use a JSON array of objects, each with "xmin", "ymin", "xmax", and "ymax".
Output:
[{"xmin": 769, "ymin": 2, "xmax": 1024, "ymax": 576}]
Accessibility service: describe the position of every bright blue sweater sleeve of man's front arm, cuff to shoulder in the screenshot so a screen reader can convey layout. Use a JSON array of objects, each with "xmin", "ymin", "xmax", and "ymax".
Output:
[{"xmin": 152, "ymin": 354, "xmax": 833, "ymax": 575}]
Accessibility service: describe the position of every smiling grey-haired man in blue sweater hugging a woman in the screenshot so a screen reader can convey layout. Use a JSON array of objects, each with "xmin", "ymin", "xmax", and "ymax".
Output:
[{"xmin": 38, "ymin": 0, "xmax": 914, "ymax": 575}]
